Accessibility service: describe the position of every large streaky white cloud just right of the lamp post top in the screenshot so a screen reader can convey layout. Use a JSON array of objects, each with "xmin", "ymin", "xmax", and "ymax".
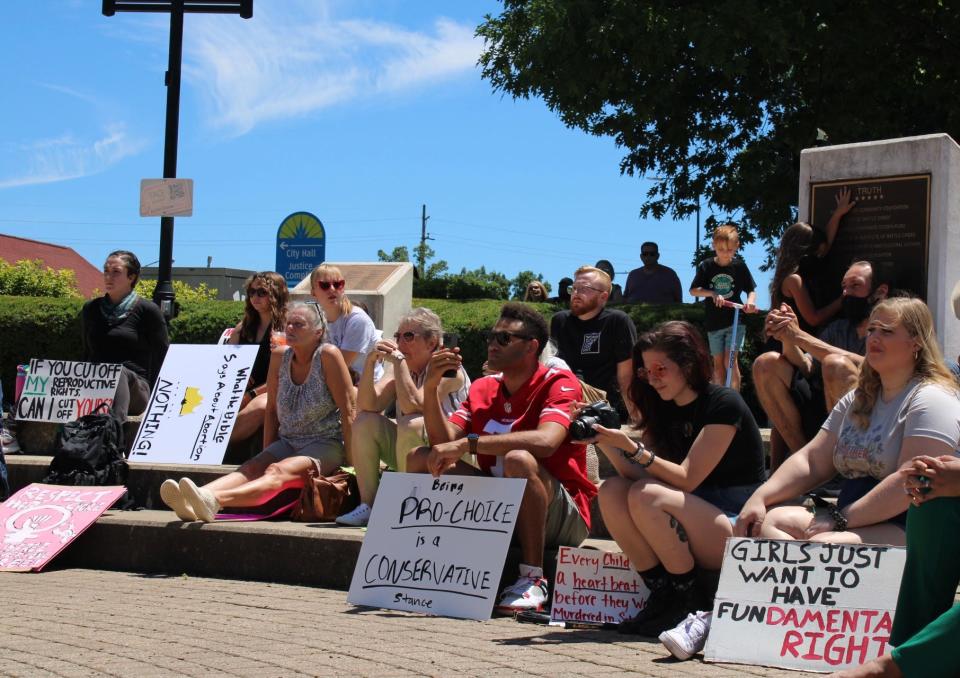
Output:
[{"xmin": 183, "ymin": 2, "xmax": 482, "ymax": 135}]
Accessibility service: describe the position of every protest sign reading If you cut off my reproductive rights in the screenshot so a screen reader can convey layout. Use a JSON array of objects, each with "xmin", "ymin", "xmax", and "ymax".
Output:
[{"xmin": 16, "ymin": 358, "xmax": 123, "ymax": 423}]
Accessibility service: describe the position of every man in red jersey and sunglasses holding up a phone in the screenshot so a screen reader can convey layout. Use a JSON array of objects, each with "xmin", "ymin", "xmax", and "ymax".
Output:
[{"xmin": 407, "ymin": 303, "xmax": 597, "ymax": 612}]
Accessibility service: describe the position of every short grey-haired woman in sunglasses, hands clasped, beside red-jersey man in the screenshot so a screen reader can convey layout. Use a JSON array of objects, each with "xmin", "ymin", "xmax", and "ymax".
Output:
[{"xmin": 337, "ymin": 308, "xmax": 470, "ymax": 527}]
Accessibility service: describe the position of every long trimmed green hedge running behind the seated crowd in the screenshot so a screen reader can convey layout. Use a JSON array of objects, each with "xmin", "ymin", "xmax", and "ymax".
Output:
[{"xmin": 0, "ymin": 296, "xmax": 763, "ymax": 424}]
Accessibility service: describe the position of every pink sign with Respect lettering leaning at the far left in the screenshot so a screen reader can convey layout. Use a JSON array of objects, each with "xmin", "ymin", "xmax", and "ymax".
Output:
[{"xmin": 0, "ymin": 483, "xmax": 127, "ymax": 572}]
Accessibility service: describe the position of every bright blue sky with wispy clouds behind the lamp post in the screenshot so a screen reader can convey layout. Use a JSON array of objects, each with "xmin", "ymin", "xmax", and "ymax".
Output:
[{"xmin": 0, "ymin": 0, "xmax": 769, "ymax": 305}]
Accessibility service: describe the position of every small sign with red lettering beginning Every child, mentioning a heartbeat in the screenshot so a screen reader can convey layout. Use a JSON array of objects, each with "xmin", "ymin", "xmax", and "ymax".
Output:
[{"xmin": 550, "ymin": 546, "xmax": 650, "ymax": 624}]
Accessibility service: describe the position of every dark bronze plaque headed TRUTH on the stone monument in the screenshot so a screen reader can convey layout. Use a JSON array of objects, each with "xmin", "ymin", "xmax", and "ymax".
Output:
[{"xmin": 810, "ymin": 174, "xmax": 930, "ymax": 300}]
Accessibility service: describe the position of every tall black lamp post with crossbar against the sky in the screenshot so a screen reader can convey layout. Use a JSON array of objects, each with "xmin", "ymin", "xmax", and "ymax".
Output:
[{"xmin": 103, "ymin": 0, "xmax": 253, "ymax": 322}]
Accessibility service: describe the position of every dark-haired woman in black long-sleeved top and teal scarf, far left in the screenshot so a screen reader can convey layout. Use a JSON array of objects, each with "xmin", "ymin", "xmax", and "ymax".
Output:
[{"xmin": 80, "ymin": 250, "xmax": 170, "ymax": 419}]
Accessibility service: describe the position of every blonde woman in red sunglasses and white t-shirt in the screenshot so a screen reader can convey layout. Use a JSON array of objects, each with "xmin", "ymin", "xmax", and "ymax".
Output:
[{"xmin": 310, "ymin": 264, "xmax": 383, "ymax": 384}]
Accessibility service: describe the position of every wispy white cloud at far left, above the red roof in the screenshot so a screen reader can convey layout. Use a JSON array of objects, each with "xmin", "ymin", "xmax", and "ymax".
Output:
[{"xmin": 0, "ymin": 123, "xmax": 146, "ymax": 189}]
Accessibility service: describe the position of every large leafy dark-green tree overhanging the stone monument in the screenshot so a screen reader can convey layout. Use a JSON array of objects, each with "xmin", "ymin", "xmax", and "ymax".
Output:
[{"xmin": 477, "ymin": 0, "xmax": 960, "ymax": 251}]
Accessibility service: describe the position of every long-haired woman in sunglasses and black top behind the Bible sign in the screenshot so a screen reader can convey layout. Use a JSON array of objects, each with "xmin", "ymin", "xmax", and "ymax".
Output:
[{"xmin": 227, "ymin": 271, "xmax": 290, "ymax": 441}]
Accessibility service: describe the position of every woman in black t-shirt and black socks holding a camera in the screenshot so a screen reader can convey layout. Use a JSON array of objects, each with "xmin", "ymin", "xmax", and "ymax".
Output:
[{"xmin": 576, "ymin": 321, "xmax": 763, "ymax": 636}]
